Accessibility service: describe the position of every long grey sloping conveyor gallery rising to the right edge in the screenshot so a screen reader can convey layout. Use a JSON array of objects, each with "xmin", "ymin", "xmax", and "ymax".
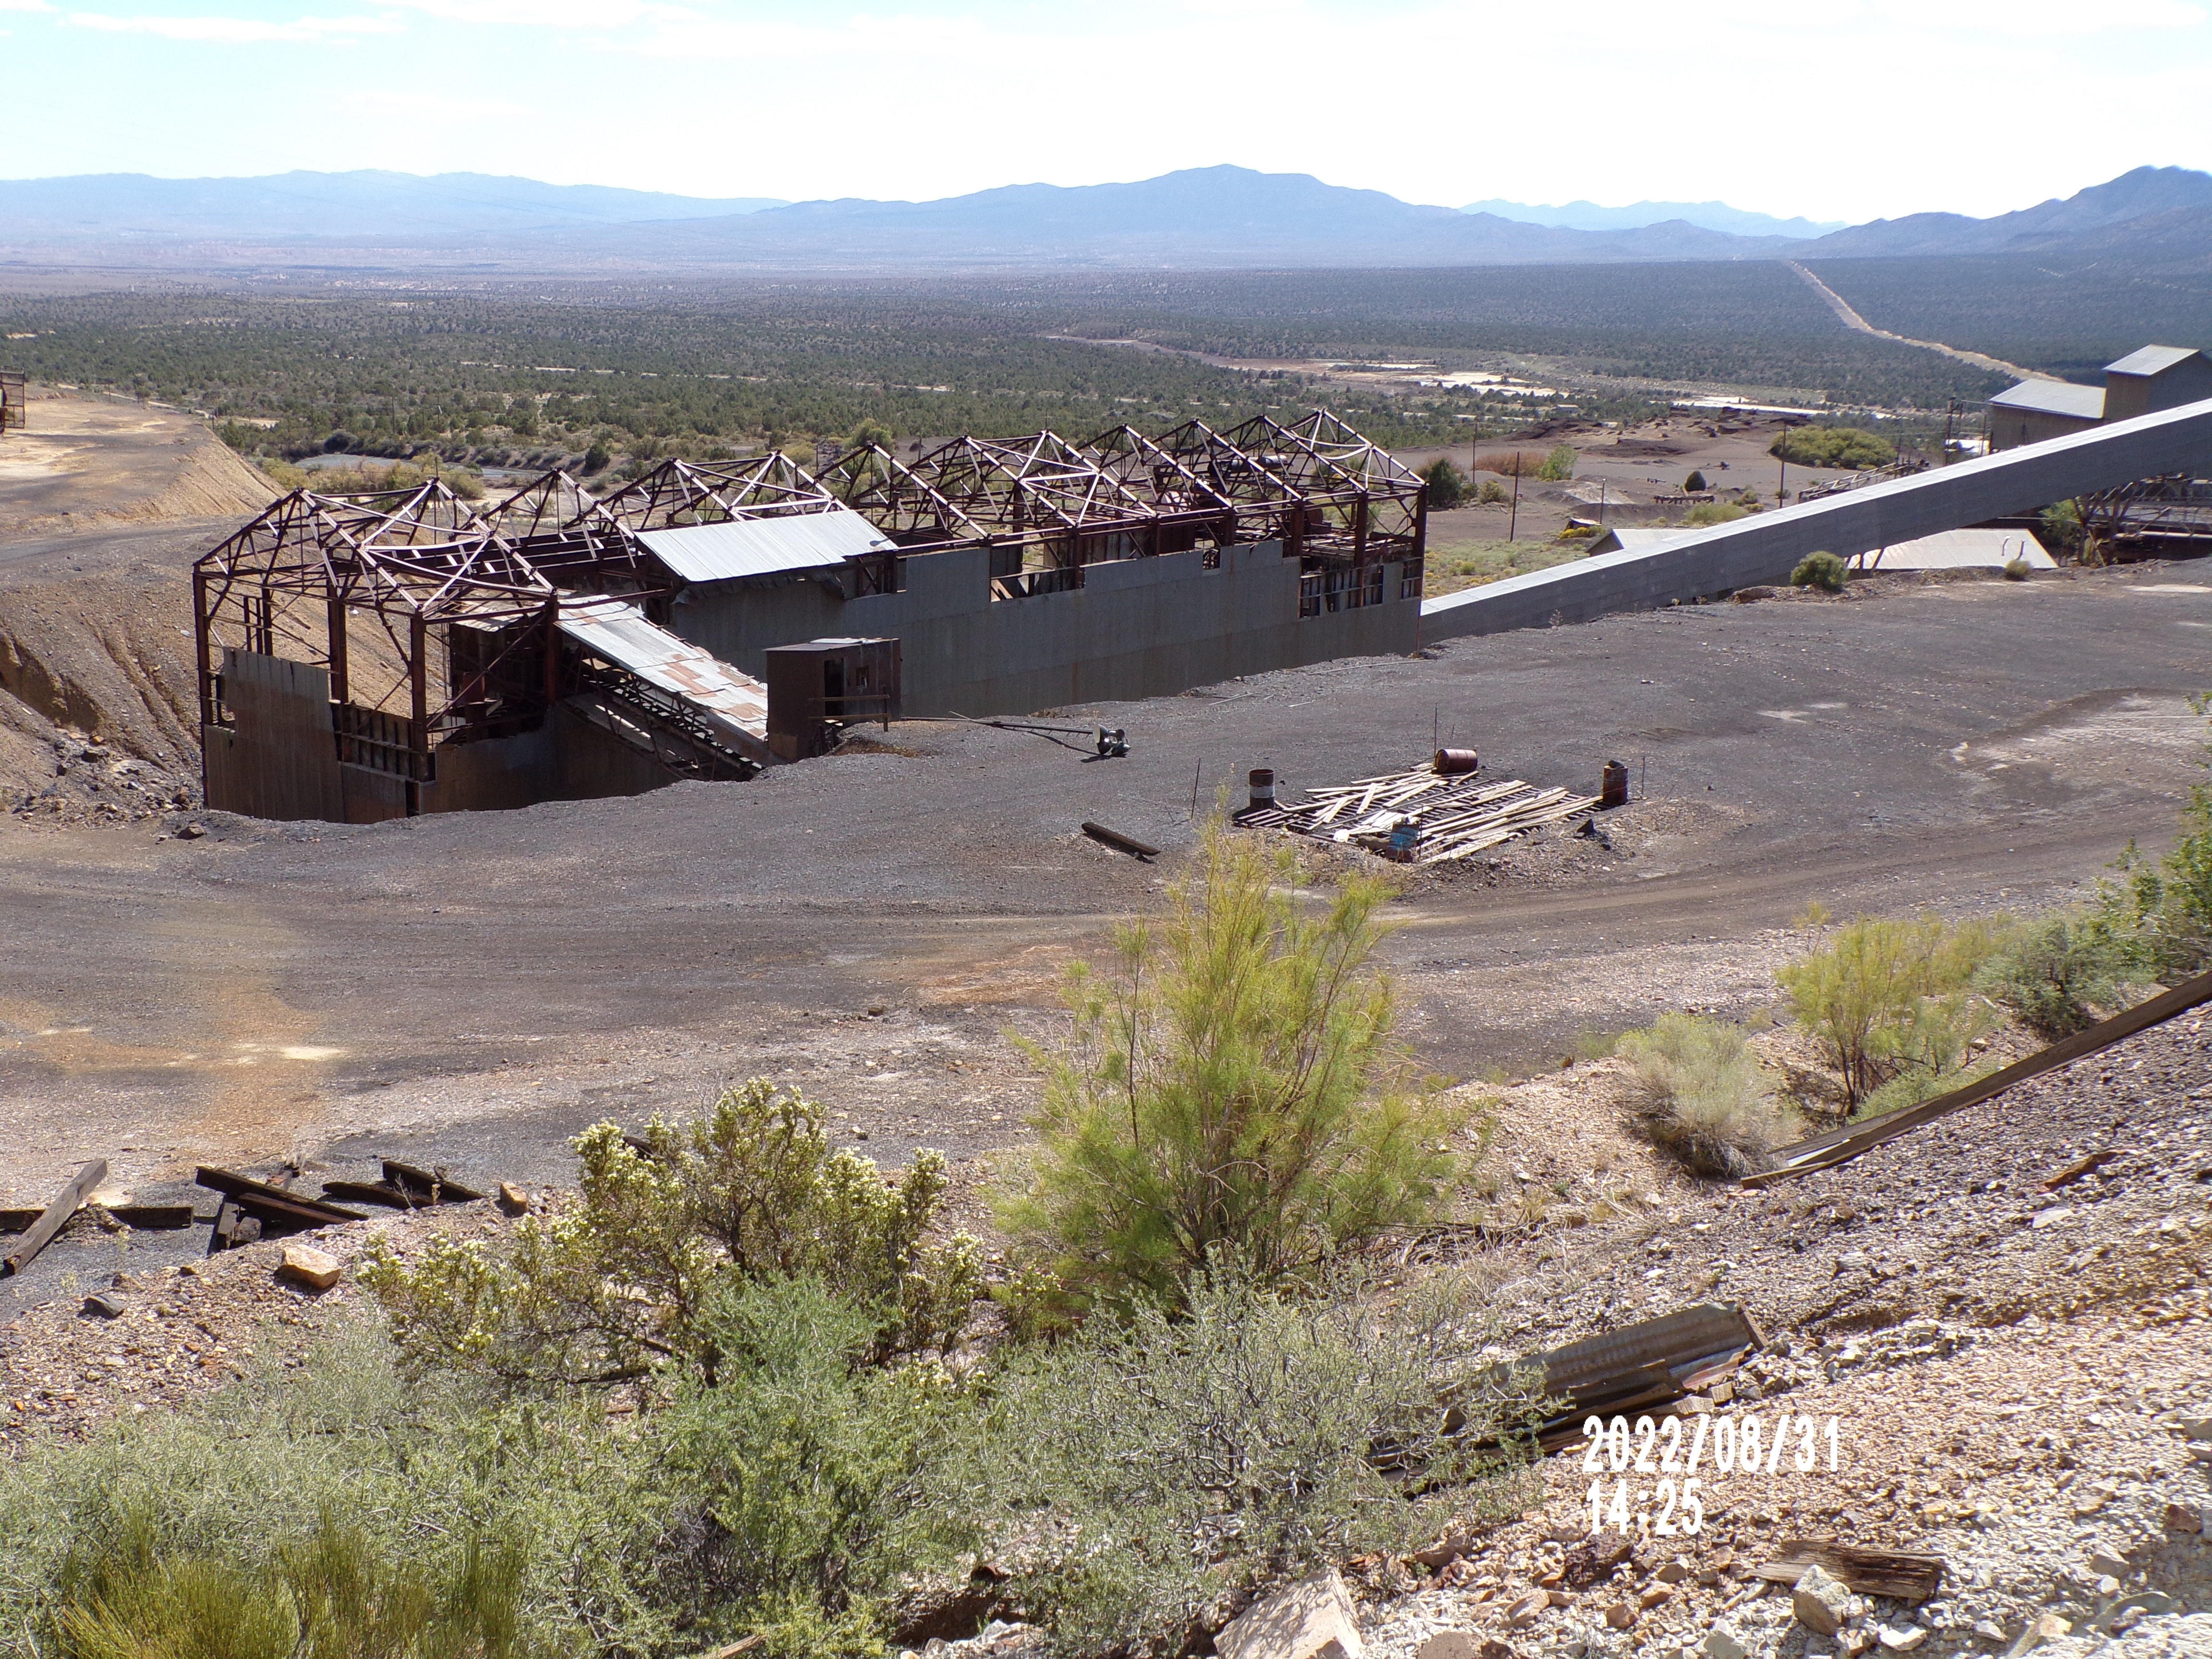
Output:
[{"xmin": 1420, "ymin": 400, "xmax": 2212, "ymax": 639}]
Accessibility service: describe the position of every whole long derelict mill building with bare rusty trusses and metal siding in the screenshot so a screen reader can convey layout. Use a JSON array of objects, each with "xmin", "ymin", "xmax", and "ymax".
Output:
[{"xmin": 192, "ymin": 409, "xmax": 1427, "ymax": 823}]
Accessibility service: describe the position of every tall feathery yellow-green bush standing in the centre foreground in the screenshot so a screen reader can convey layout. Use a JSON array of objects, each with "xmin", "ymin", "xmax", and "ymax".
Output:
[{"xmin": 1000, "ymin": 821, "xmax": 1464, "ymax": 1301}]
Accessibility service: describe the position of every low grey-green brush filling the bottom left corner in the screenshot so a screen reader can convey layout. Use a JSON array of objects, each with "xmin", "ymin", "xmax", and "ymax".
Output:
[{"xmin": 0, "ymin": 1321, "xmax": 681, "ymax": 1659}]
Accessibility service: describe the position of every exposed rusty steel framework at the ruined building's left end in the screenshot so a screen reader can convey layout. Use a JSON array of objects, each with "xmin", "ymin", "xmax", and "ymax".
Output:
[{"xmin": 192, "ymin": 480, "xmax": 560, "ymax": 781}]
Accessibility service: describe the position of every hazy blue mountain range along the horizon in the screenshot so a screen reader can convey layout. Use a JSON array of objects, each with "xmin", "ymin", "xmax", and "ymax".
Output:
[{"xmin": 0, "ymin": 166, "xmax": 2212, "ymax": 272}]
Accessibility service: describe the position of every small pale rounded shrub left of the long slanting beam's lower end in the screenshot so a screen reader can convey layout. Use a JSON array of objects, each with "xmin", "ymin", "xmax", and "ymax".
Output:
[{"xmin": 1615, "ymin": 1013, "xmax": 1798, "ymax": 1177}]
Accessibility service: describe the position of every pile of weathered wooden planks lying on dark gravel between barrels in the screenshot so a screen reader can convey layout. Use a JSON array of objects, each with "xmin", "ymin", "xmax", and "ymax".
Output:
[{"xmin": 1237, "ymin": 765, "xmax": 1597, "ymax": 865}]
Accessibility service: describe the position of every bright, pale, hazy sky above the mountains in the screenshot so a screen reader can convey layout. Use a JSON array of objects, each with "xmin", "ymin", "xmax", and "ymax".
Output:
[{"xmin": 0, "ymin": 0, "xmax": 2212, "ymax": 221}]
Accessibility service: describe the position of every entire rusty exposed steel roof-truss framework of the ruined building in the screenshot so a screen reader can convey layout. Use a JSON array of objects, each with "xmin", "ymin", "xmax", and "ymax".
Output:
[{"xmin": 192, "ymin": 409, "xmax": 1427, "ymax": 779}]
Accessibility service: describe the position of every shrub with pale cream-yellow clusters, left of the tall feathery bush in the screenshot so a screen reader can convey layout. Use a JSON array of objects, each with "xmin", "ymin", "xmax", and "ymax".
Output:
[{"xmin": 361, "ymin": 1077, "xmax": 980, "ymax": 1385}]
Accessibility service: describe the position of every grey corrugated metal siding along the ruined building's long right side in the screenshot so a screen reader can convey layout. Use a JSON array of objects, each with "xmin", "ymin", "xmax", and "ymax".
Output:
[{"xmin": 673, "ymin": 542, "xmax": 1420, "ymax": 714}]
